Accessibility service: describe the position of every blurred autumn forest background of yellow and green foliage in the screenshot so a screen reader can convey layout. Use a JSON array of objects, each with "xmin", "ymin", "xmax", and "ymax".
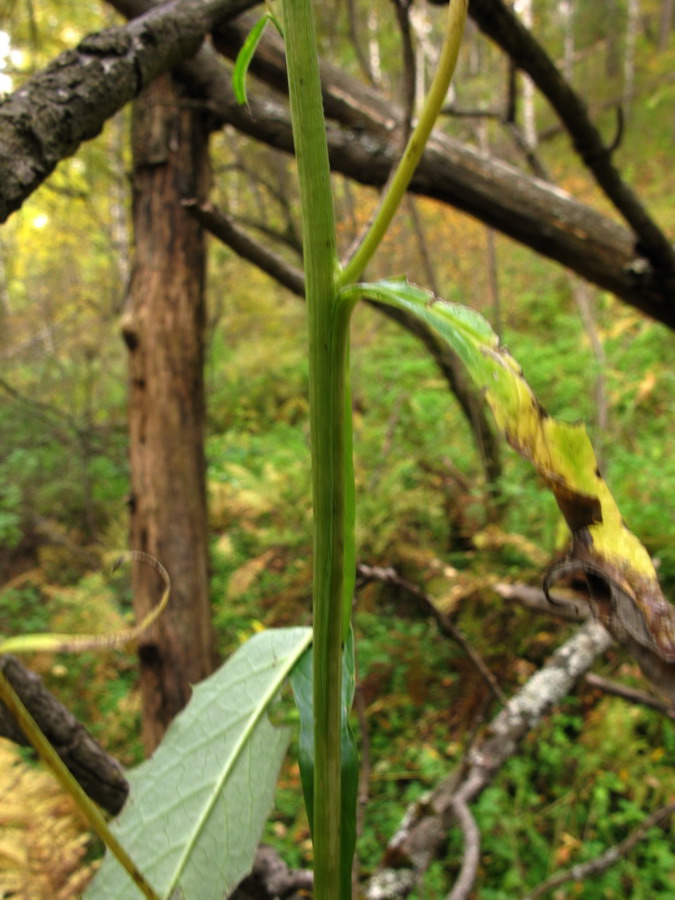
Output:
[{"xmin": 0, "ymin": 0, "xmax": 675, "ymax": 900}]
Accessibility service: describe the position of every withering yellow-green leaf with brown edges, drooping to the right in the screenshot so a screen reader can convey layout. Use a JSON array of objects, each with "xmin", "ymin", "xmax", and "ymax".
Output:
[{"xmin": 352, "ymin": 278, "xmax": 675, "ymax": 699}]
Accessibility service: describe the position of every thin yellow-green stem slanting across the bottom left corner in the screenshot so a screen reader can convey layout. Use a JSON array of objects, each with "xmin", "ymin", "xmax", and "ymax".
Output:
[{"xmin": 0, "ymin": 670, "xmax": 160, "ymax": 900}]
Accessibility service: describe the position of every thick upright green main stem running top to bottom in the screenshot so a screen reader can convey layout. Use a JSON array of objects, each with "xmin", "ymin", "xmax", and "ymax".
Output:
[{"xmin": 283, "ymin": 0, "xmax": 354, "ymax": 900}]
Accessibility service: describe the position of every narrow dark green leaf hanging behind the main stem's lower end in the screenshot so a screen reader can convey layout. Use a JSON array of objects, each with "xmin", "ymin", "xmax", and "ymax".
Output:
[{"xmin": 291, "ymin": 629, "xmax": 359, "ymax": 898}]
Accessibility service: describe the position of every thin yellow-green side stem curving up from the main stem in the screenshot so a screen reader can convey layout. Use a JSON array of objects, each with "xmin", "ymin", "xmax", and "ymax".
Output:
[{"xmin": 339, "ymin": 0, "xmax": 468, "ymax": 287}]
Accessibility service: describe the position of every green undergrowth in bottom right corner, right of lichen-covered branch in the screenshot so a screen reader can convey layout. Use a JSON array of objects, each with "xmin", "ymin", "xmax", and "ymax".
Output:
[{"xmin": 444, "ymin": 691, "xmax": 675, "ymax": 900}]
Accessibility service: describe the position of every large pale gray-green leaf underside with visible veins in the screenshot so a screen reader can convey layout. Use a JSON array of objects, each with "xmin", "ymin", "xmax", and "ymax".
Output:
[{"xmin": 85, "ymin": 628, "xmax": 312, "ymax": 900}]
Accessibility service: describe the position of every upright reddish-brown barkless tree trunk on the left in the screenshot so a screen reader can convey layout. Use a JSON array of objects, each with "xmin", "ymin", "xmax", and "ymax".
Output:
[{"xmin": 123, "ymin": 75, "xmax": 216, "ymax": 752}]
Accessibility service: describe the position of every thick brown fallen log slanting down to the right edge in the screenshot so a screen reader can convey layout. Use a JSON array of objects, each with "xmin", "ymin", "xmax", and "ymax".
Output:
[{"xmin": 212, "ymin": 13, "xmax": 675, "ymax": 328}]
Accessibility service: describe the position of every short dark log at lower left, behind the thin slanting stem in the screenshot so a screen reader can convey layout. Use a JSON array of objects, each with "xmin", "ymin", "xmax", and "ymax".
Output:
[{"xmin": 0, "ymin": 656, "xmax": 129, "ymax": 815}]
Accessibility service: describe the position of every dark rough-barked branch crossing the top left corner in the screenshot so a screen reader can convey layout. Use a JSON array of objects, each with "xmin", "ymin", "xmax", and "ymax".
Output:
[{"xmin": 0, "ymin": 0, "xmax": 254, "ymax": 222}]
